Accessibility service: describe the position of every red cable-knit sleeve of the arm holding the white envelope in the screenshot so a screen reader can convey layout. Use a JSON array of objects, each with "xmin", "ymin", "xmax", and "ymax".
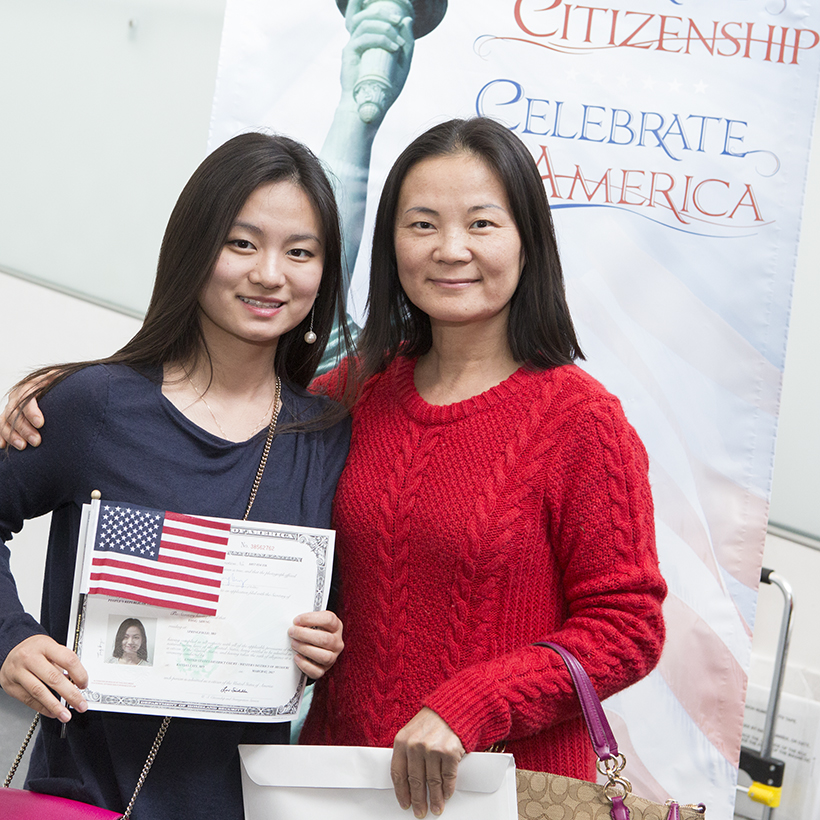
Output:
[{"xmin": 424, "ymin": 397, "xmax": 666, "ymax": 751}]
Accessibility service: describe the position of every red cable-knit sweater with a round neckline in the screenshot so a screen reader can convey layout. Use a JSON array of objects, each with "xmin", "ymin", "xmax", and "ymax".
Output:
[{"xmin": 301, "ymin": 357, "xmax": 666, "ymax": 780}]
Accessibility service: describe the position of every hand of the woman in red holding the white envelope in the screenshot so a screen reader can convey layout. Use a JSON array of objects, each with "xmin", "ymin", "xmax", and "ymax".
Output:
[{"xmin": 390, "ymin": 707, "xmax": 465, "ymax": 818}]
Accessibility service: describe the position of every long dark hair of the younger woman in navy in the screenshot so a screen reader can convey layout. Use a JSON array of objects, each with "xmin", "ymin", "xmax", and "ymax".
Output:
[{"xmin": 12, "ymin": 133, "xmax": 351, "ymax": 416}]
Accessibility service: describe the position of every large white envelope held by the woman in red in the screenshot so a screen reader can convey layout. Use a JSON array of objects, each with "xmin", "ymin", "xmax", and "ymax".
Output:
[{"xmin": 239, "ymin": 746, "xmax": 518, "ymax": 820}]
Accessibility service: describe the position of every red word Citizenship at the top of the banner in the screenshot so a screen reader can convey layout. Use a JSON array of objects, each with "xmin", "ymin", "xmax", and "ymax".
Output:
[{"xmin": 512, "ymin": 0, "xmax": 820, "ymax": 65}]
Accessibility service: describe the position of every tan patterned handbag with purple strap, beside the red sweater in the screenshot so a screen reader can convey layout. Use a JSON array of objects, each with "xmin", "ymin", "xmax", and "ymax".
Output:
[{"xmin": 515, "ymin": 642, "xmax": 706, "ymax": 820}]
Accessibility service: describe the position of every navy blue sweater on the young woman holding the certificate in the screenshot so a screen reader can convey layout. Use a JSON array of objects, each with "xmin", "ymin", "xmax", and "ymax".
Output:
[{"xmin": 0, "ymin": 365, "xmax": 350, "ymax": 820}]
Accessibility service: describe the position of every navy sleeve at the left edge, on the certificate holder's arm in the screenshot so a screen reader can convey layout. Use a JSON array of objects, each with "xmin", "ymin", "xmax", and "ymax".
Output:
[{"xmin": 0, "ymin": 367, "xmax": 108, "ymax": 665}]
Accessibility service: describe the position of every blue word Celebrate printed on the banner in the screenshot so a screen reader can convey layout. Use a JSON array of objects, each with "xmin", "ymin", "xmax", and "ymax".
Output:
[{"xmin": 476, "ymin": 79, "xmax": 757, "ymax": 161}]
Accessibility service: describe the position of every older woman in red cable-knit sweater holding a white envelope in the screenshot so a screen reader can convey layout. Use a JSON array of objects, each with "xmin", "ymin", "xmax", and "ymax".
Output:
[{"xmin": 302, "ymin": 119, "xmax": 666, "ymax": 817}]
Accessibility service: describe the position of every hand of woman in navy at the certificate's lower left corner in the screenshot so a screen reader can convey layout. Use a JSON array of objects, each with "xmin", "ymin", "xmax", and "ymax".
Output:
[{"xmin": 0, "ymin": 635, "xmax": 88, "ymax": 723}]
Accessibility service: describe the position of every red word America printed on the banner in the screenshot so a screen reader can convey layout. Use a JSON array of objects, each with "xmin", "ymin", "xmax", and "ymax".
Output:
[{"xmin": 535, "ymin": 145, "xmax": 766, "ymax": 229}]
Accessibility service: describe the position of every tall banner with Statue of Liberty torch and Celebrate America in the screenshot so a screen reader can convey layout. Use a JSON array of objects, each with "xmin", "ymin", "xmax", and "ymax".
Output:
[{"xmin": 211, "ymin": 0, "xmax": 820, "ymax": 820}]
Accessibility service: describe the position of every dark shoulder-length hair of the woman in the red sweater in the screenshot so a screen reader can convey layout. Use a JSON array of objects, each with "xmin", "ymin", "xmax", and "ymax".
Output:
[{"xmin": 359, "ymin": 117, "xmax": 584, "ymax": 378}]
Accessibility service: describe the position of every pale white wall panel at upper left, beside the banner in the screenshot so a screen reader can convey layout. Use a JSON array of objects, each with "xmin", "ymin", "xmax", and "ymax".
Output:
[{"xmin": 0, "ymin": 0, "xmax": 225, "ymax": 318}]
